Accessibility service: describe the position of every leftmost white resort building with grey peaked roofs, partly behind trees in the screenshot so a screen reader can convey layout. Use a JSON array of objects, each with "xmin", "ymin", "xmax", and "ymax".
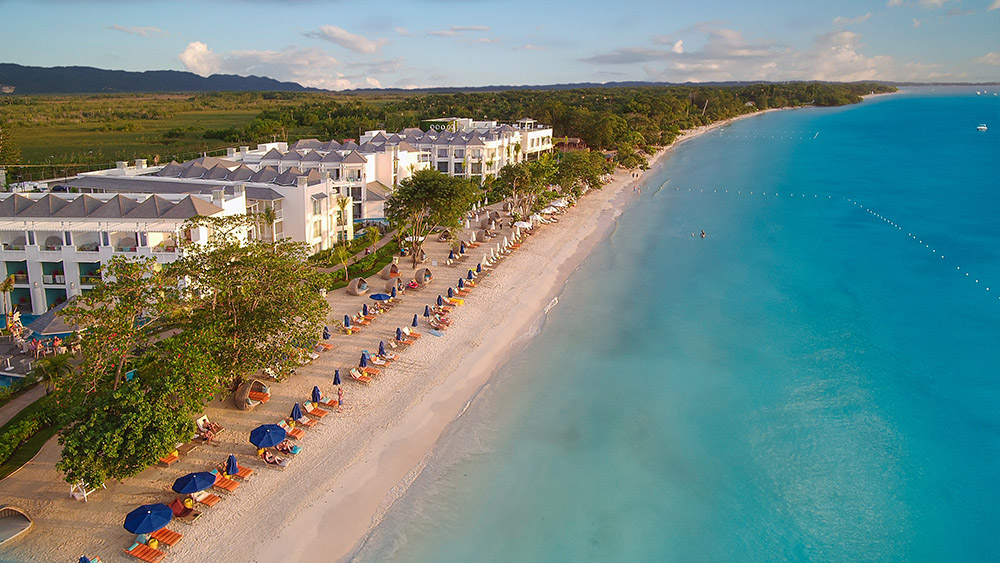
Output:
[{"xmin": 0, "ymin": 189, "xmax": 246, "ymax": 315}]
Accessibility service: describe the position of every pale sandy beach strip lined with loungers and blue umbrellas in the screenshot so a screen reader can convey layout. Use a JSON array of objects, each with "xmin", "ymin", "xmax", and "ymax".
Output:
[{"xmin": 0, "ymin": 112, "xmax": 765, "ymax": 562}]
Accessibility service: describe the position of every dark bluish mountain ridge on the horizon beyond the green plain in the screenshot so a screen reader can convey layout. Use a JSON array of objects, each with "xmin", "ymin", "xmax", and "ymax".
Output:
[{"xmin": 0, "ymin": 63, "xmax": 317, "ymax": 94}]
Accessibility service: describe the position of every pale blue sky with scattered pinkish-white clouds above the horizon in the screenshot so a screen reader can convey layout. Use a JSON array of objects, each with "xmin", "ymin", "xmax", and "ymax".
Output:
[{"xmin": 0, "ymin": 0, "xmax": 1000, "ymax": 90}]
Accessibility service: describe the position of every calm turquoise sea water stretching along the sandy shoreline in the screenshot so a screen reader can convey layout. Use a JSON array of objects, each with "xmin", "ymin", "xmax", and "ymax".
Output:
[{"xmin": 357, "ymin": 89, "xmax": 1000, "ymax": 562}]
